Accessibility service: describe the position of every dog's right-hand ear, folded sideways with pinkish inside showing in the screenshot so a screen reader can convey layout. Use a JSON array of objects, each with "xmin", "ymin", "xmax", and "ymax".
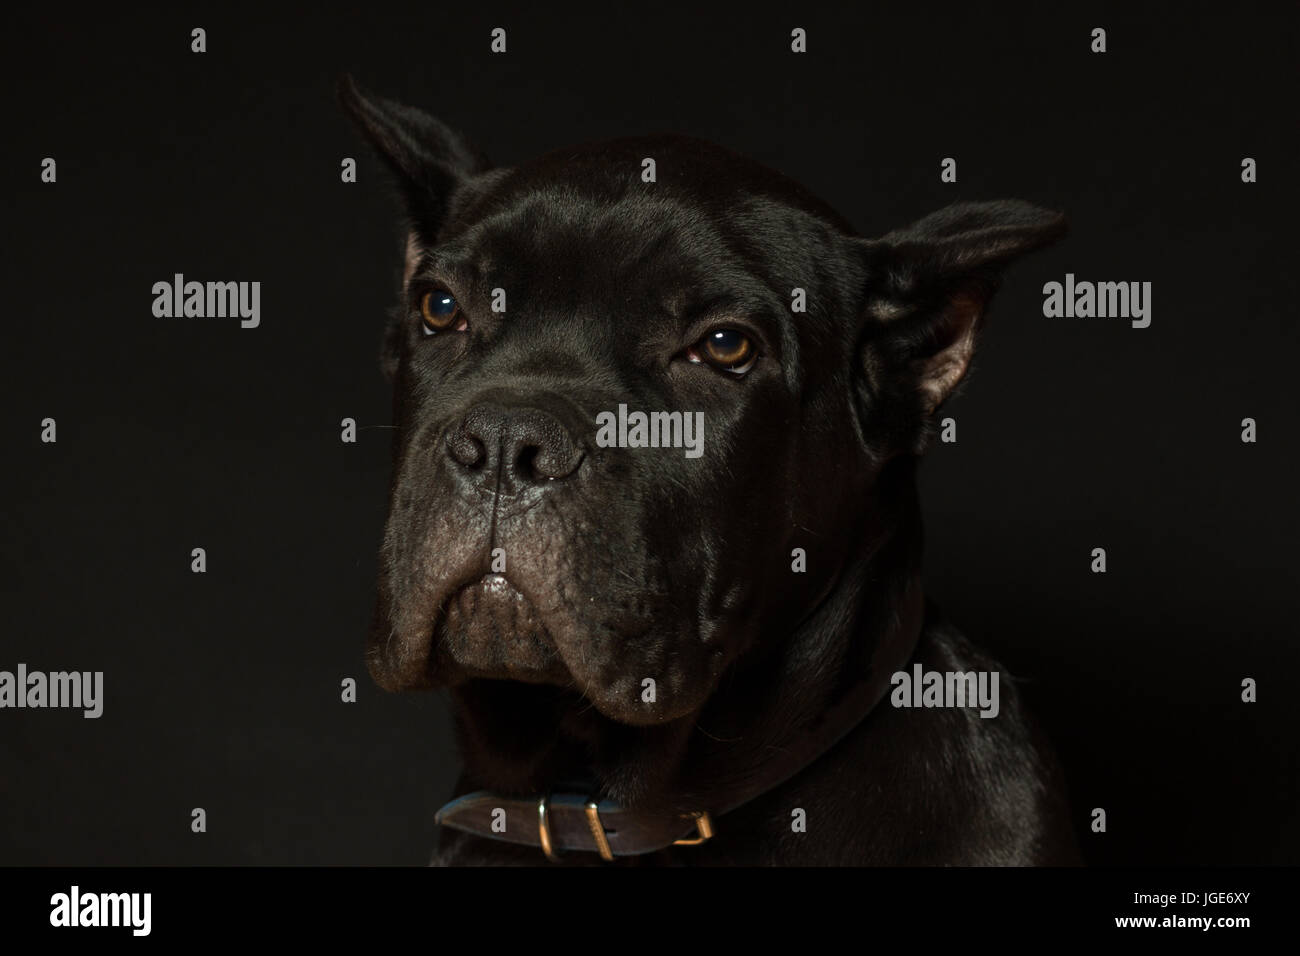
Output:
[{"xmin": 857, "ymin": 200, "xmax": 1066, "ymax": 454}]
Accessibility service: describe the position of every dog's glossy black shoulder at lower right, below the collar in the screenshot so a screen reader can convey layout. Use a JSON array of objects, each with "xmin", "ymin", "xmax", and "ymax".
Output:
[{"xmin": 719, "ymin": 606, "xmax": 1078, "ymax": 865}]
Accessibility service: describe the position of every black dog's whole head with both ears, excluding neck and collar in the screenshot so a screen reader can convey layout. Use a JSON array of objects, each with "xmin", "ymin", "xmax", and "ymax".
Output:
[{"xmin": 342, "ymin": 76, "xmax": 1062, "ymax": 726}]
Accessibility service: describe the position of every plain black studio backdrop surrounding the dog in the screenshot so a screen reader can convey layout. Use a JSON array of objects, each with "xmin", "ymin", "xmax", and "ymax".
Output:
[{"xmin": 0, "ymin": 4, "xmax": 1300, "ymax": 864}]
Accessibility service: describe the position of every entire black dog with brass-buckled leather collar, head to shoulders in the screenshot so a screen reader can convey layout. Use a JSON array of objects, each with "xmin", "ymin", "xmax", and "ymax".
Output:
[{"xmin": 339, "ymin": 78, "xmax": 1074, "ymax": 865}]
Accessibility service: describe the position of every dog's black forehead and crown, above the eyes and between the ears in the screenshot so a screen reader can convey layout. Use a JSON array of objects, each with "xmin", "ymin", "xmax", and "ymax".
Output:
[{"xmin": 418, "ymin": 135, "xmax": 852, "ymax": 335}]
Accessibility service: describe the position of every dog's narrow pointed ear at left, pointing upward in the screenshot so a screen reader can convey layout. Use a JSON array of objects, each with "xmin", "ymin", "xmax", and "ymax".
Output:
[{"xmin": 338, "ymin": 73, "xmax": 491, "ymax": 232}]
